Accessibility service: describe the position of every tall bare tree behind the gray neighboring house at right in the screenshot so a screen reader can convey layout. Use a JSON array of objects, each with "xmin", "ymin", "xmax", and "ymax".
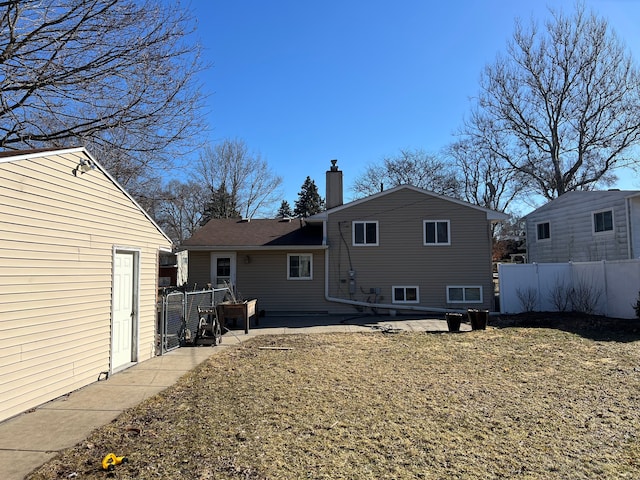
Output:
[{"xmin": 465, "ymin": 5, "xmax": 640, "ymax": 199}]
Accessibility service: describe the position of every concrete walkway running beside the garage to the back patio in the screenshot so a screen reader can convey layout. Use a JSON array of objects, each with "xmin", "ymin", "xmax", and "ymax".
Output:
[{"xmin": 0, "ymin": 316, "xmax": 460, "ymax": 480}]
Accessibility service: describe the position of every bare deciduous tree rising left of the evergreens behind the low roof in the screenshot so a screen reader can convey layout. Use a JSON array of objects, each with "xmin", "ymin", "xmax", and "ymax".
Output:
[{"xmin": 197, "ymin": 139, "xmax": 282, "ymax": 218}]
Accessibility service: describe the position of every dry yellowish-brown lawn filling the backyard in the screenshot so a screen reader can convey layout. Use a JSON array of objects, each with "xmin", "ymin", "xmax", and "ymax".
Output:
[{"xmin": 28, "ymin": 328, "xmax": 640, "ymax": 480}]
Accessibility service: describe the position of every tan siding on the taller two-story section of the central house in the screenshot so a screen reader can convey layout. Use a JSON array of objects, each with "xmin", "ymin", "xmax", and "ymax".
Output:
[{"xmin": 327, "ymin": 189, "xmax": 493, "ymax": 308}]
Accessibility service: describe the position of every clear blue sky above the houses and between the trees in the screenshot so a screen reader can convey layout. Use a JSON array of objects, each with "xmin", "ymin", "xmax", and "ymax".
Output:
[{"xmin": 191, "ymin": 0, "xmax": 640, "ymax": 212}]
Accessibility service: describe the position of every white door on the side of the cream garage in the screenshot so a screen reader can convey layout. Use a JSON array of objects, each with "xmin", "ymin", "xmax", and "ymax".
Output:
[{"xmin": 111, "ymin": 252, "xmax": 136, "ymax": 370}]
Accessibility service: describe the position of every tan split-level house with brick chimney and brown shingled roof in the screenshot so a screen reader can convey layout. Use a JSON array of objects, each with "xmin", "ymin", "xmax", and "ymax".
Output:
[{"xmin": 182, "ymin": 162, "xmax": 507, "ymax": 315}]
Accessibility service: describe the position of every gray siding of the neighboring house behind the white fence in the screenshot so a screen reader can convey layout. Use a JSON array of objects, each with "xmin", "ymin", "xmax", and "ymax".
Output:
[{"xmin": 527, "ymin": 192, "xmax": 631, "ymax": 263}]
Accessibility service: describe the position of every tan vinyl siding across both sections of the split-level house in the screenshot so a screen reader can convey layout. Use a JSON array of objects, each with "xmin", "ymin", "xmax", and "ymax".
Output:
[{"xmin": 182, "ymin": 189, "xmax": 493, "ymax": 315}]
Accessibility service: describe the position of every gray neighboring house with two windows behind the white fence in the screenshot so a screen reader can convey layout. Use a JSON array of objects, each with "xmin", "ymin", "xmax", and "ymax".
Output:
[{"xmin": 525, "ymin": 190, "xmax": 640, "ymax": 263}]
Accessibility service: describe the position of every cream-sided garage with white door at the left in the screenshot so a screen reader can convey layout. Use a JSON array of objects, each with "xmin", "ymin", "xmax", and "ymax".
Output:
[{"xmin": 0, "ymin": 147, "xmax": 172, "ymax": 420}]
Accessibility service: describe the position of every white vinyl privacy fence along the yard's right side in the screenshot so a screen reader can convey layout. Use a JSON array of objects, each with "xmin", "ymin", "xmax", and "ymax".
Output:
[{"xmin": 498, "ymin": 260, "xmax": 640, "ymax": 318}]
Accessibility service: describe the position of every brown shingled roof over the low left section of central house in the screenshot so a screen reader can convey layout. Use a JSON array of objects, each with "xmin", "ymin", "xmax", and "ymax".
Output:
[{"xmin": 182, "ymin": 218, "xmax": 322, "ymax": 249}]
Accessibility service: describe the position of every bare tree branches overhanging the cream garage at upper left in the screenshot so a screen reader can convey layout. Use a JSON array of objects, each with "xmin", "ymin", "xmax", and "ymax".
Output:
[{"xmin": 0, "ymin": 0, "xmax": 202, "ymax": 195}]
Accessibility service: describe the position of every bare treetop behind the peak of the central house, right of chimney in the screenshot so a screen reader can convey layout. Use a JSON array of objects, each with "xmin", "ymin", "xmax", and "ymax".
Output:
[{"xmin": 352, "ymin": 149, "xmax": 459, "ymax": 198}]
